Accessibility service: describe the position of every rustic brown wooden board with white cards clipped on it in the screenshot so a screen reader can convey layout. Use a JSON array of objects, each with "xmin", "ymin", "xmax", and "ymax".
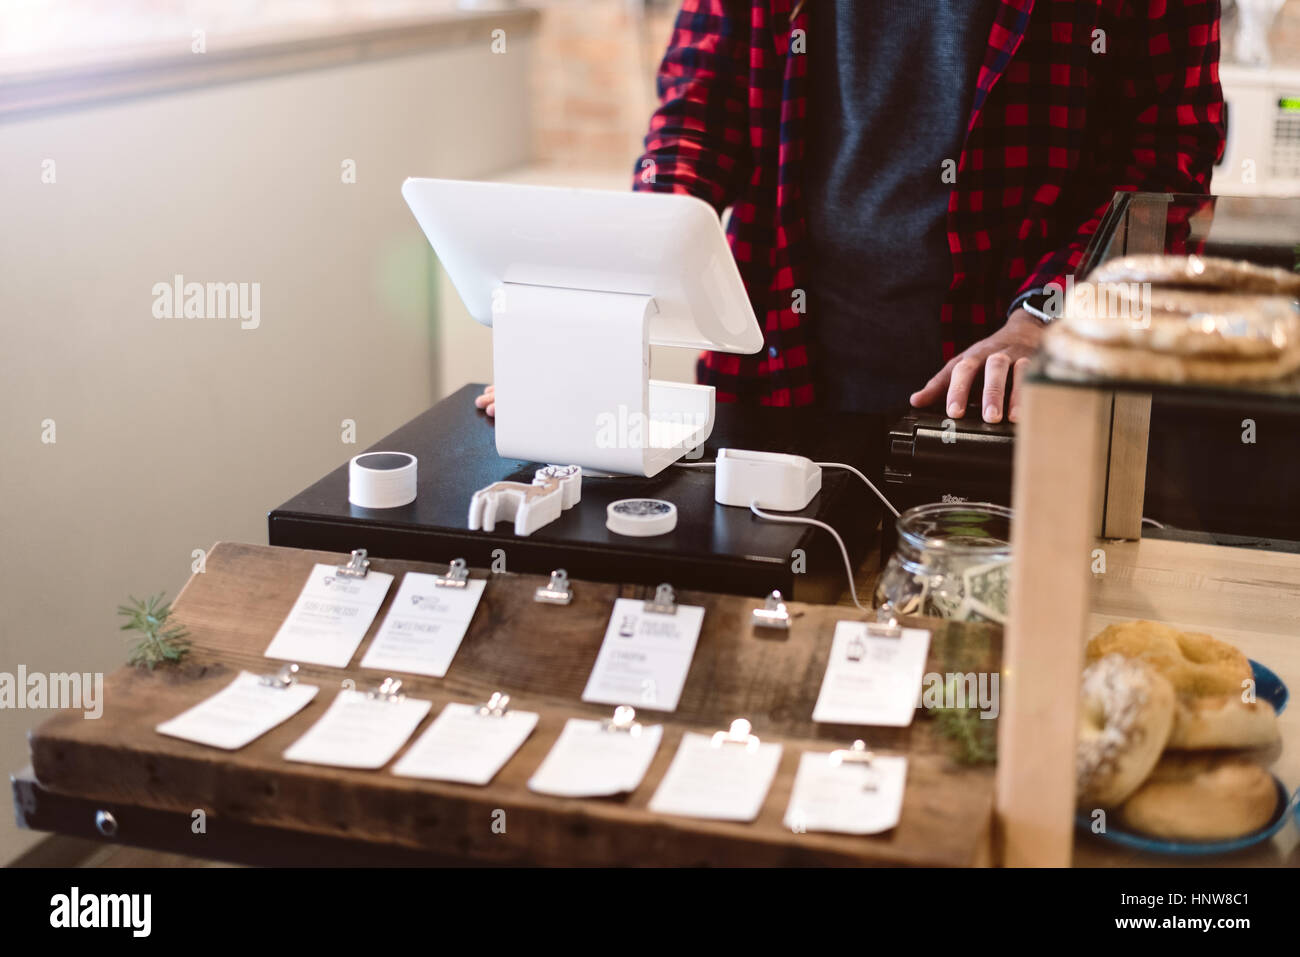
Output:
[{"xmin": 16, "ymin": 544, "xmax": 1001, "ymax": 865}]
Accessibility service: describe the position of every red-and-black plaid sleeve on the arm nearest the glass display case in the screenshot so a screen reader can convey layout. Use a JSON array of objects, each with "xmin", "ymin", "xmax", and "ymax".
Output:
[{"xmin": 1018, "ymin": 0, "xmax": 1225, "ymax": 298}]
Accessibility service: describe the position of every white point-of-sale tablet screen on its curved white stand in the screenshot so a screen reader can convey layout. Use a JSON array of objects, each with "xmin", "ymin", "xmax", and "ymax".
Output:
[{"xmin": 402, "ymin": 179, "xmax": 763, "ymax": 476}]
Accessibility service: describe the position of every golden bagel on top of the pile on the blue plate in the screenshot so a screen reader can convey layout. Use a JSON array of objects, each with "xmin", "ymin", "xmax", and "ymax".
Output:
[{"xmin": 1086, "ymin": 622, "xmax": 1253, "ymax": 697}]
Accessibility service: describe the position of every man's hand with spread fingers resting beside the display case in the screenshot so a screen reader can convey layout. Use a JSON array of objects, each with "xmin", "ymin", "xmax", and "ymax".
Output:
[{"xmin": 911, "ymin": 309, "xmax": 1043, "ymax": 423}]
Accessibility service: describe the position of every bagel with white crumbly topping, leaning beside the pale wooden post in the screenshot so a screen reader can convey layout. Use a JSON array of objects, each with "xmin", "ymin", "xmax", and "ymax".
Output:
[{"xmin": 1075, "ymin": 654, "xmax": 1174, "ymax": 807}]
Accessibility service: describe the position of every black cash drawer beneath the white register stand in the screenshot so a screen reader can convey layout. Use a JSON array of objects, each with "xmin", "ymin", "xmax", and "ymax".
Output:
[{"xmin": 268, "ymin": 386, "xmax": 885, "ymax": 602}]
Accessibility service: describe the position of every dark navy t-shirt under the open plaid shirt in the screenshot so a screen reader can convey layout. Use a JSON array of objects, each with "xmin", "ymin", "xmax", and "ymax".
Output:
[{"xmin": 803, "ymin": 0, "xmax": 998, "ymax": 412}]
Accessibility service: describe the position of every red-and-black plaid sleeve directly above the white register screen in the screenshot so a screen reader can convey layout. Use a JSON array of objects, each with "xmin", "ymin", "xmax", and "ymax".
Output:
[{"xmin": 633, "ymin": 0, "xmax": 750, "ymax": 212}]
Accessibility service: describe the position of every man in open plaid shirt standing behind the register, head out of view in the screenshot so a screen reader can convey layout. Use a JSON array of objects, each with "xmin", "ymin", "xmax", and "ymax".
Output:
[{"xmin": 478, "ymin": 0, "xmax": 1225, "ymax": 421}]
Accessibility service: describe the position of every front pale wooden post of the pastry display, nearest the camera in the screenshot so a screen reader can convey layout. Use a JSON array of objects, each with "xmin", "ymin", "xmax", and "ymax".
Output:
[{"xmin": 996, "ymin": 382, "xmax": 1112, "ymax": 867}]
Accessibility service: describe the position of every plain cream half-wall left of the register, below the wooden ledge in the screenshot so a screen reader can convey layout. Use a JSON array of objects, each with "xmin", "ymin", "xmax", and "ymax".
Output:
[{"xmin": 0, "ymin": 40, "xmax": 530, "ymax": 862}]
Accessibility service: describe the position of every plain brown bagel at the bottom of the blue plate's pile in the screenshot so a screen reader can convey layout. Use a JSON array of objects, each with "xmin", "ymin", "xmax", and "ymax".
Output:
[{"xmin": 1119, "ymin": 752, "xmax": 1278, "ymax": 841}]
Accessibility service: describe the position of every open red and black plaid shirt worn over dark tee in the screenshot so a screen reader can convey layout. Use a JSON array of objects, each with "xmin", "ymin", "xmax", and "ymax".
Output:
[{"xmin": 634, "ymin": 0, "xmax": 1223, "ymax": 406}]
